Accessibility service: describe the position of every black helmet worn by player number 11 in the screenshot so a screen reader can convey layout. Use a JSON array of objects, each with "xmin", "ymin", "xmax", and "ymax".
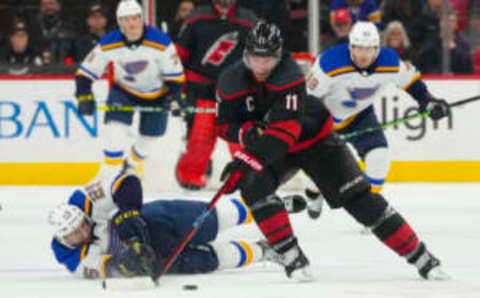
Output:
[{"xmin": 245, "ymin": 21, "xmax": 283, "ymax": 59}]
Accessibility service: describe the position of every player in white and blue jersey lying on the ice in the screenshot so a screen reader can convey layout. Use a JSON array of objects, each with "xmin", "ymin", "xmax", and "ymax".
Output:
[{"xmin": 48, "ymin": 167, "xmax": 305, "ymax": 278}]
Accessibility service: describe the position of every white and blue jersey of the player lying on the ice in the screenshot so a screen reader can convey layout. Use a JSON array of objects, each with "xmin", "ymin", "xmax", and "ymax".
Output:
[{"xmin": 51, "ymin": 179, "xmax": 121, "ymax": 278}]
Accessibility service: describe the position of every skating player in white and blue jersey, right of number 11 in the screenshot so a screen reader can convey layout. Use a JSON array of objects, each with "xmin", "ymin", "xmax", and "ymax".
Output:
[{"xmin": 307, "ymin": 22, "xmax": 450, "ymax": 219}]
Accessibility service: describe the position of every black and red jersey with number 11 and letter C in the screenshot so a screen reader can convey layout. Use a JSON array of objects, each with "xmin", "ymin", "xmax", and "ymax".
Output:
[{"xmin": 216, "ymin": 53, "xmax": 333, "ymax": 164}]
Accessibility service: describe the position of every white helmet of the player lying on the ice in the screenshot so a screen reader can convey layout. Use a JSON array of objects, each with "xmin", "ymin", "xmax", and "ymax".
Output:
[{"xmin": 48, "ymin": 203, "xmax": 88, "ymax": 248}]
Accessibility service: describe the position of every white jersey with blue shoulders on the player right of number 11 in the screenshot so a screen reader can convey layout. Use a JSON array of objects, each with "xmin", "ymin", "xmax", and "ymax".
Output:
[{"xmin": 307, "ymin": 44, "xmax": 421, "ymax": 129}]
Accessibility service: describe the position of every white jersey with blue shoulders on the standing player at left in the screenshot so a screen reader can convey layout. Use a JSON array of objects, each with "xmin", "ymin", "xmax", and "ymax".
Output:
[{"xmin": 77, "ymin": 26, "xmax": 185, "ymax": 100}]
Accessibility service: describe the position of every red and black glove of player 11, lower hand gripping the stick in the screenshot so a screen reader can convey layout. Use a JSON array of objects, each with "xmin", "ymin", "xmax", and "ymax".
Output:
[{"xmin": 220, "ymin": 150, "xmax": 264, "ymax": 194}]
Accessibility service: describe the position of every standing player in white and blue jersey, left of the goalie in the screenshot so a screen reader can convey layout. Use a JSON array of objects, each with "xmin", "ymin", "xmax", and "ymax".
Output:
[{"xmin": 76, "ymin": 0, "xmax": 185, "ymax": 189}]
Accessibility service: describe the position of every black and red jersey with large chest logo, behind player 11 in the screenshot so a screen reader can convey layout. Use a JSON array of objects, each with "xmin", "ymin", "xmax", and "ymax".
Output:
[{"xmin": 176, "ymin": 5, "xmax": 256, "ymax": 83}]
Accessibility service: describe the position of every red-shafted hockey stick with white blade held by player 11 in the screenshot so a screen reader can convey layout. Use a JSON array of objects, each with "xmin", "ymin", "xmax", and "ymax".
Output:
[{"xmin": 102, "ymin": 172, "xmax": 242, "ymax": 290}]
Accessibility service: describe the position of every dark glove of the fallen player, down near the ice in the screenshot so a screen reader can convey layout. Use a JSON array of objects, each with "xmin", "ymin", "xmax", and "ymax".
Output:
[{"xmin": 105, "ymin": 242, "xmax": 157, "ymax": 277}]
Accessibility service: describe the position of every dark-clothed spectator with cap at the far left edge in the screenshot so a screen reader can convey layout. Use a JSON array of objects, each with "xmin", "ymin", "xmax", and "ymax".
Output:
[{"xmin": 0, "ymin": 20, "xmax": 42, "ymax": 75}]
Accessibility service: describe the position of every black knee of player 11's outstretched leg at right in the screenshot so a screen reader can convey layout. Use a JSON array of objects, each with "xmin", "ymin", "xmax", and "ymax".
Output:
[{"xmin": 344, "ymin": 191, "xmax": 388, "ymax": 227}]
